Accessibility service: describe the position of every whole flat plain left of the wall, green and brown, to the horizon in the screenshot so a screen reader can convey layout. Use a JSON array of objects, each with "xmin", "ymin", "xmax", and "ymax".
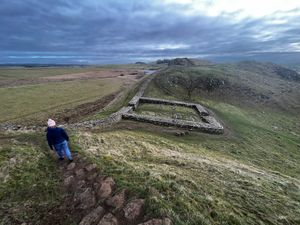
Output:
[{"xmin": 0, "ymin": 65, "xmax": 151, "ymax": 124}]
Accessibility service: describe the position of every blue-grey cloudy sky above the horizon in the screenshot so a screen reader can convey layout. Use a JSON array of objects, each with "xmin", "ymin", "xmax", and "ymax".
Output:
[{"xmin": 0, "ymin": 0, "xmax": 300, "ymax": 64}]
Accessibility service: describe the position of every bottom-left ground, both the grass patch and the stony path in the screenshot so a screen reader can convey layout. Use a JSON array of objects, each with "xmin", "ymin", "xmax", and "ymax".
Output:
[{"xmin": 0, "ymin": 132, "xmax": 171, "ymax": 225}]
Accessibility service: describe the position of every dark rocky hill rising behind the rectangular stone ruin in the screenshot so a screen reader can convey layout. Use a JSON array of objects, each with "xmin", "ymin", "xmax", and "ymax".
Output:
[{"xmin": 145, "ymin": 62, "xmax": 300, "ymax": 113}]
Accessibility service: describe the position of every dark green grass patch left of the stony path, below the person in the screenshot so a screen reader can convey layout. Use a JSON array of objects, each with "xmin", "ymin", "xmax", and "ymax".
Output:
[{"xmin": 0, "ymin": 133, "xmax": 64, "ymax": 224}]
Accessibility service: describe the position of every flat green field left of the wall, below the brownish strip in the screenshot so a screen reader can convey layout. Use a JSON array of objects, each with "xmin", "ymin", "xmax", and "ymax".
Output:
[{"xmin": 0, "ymin": 79, "xmax": 122, "ymax": 122}]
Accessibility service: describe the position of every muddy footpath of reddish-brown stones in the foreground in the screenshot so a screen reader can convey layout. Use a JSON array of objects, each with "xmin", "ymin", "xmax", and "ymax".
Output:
[{"xmin": 41, "ymin": 155, "xmax": 171, "ymax": 225}]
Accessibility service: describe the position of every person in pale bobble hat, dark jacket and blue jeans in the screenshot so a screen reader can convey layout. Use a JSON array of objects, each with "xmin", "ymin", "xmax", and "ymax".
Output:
[{"xmin": 47, "ymin": 119, "xmax": 73, "ymax": 162}]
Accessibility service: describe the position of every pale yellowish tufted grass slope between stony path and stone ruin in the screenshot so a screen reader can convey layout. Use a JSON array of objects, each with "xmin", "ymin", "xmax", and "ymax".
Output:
[{"xmin": 77, "ymin": 124, "xmax": 300, "ymax": 225}]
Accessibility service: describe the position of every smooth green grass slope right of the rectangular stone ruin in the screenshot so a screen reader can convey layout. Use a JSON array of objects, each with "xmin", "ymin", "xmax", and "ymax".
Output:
[{"xmin": 202, "ymin": 102, "xmax": 300, "ymax": 179}]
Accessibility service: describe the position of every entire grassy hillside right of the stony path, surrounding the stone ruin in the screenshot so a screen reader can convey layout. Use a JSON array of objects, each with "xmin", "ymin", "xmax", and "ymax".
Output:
[{"xmin": 73, "ymin": 60, "xmax": 300, "ymax": 225}]
